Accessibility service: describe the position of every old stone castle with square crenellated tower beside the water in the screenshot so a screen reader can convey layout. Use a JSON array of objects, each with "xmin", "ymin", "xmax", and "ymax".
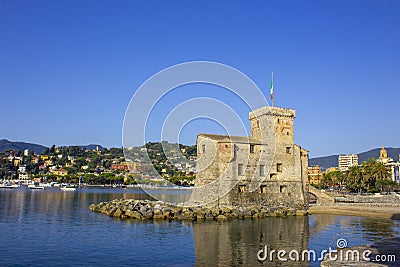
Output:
[{"xmin": 191, "ymin": 106, "xmax": 308, "ymax": 210}]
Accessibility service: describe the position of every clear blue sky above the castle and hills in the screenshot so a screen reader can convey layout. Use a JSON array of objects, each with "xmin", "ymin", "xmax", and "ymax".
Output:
[{"xmin": 0, "ymin": 0, "xmax": 400, "ymax": 157}]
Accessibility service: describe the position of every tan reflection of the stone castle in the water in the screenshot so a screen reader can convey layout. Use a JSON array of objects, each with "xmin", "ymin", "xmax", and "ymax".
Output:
[{"xmin": 193, "ymin": 217, "xmax": 309, "ymax": 266}]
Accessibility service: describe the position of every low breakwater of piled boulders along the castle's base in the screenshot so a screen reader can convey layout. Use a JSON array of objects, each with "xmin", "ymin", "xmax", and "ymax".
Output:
[{"xmin": 89, "ymin": 199, "xmax": 307, "ymax": 221}]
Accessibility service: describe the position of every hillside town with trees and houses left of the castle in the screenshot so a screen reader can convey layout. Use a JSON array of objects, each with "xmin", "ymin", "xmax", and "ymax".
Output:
[{"xmin": 0, "ymin": 142, "xmax": 196, "ymax": 186}]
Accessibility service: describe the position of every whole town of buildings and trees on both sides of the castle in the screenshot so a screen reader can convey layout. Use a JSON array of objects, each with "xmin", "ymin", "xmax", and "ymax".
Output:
[{"xmin": 0, "ymin": 139, "xmax": 400, "ymax": 193}]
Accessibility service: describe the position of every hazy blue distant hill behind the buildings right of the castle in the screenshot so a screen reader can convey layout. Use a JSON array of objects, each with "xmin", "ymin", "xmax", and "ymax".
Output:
[{"xmin": 308, "ymin": 147, "xmax": 400, "ymax": 169}]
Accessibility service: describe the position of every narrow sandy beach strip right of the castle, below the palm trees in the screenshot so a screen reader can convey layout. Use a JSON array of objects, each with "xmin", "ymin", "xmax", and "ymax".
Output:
[{"xmin": 308, "ymin": 203, "xmax": 400, "ymax": 220}]
